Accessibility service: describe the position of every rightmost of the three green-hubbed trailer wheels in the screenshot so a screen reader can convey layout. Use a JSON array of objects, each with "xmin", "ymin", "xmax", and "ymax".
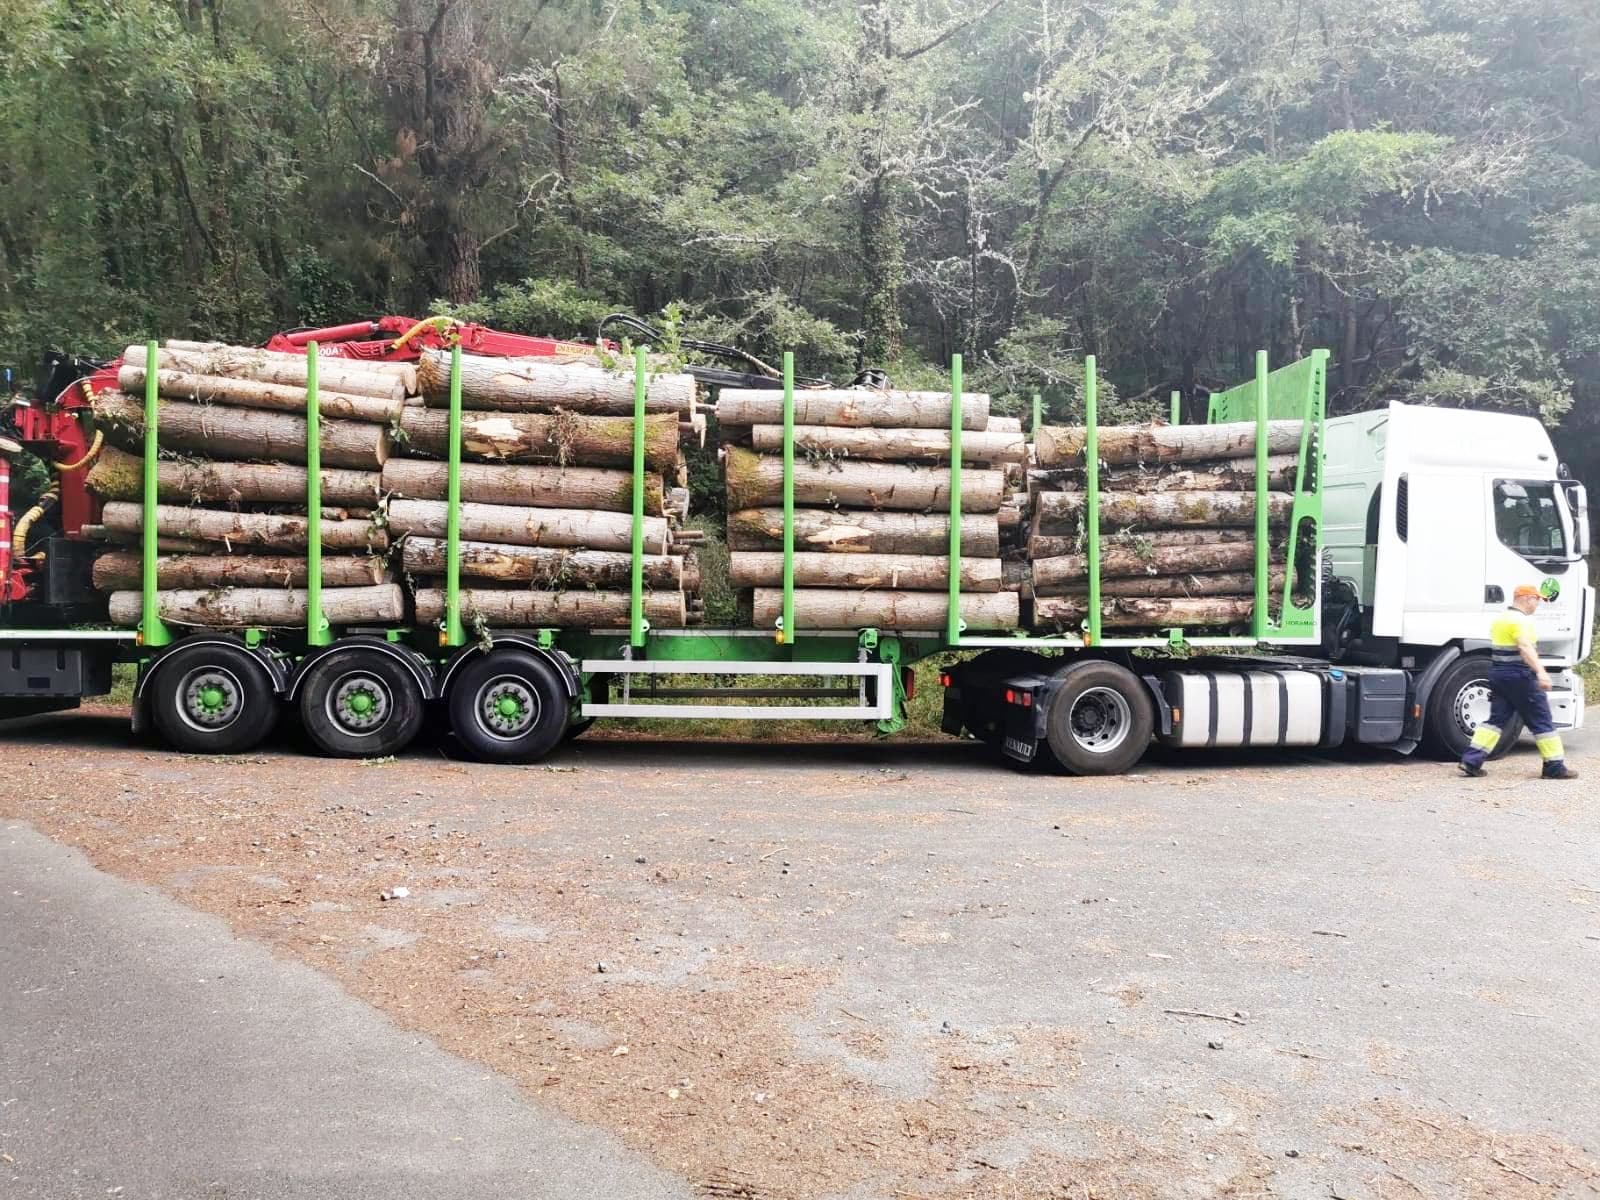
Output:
[{"xmin": 446, "ymin": 650, "xmax": 571, "ymax": 763}]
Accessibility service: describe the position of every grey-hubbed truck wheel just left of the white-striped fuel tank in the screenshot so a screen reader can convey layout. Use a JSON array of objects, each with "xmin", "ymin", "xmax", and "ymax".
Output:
[{"xmin": 1045, "ymin": 662, "xmax": 1155, "ymax": 774}]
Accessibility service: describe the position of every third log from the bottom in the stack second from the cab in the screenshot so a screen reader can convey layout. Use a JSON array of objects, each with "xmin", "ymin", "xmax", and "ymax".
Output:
[{"xmin": 728, "ymin": 509, "xmax": 1000, "ymax": 558}]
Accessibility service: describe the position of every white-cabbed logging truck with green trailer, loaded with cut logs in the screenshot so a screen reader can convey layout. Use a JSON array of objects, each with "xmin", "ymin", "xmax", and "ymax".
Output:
[{"xmin": 0, "ymin": 318, "xmax": 1594, "ymax": 774}]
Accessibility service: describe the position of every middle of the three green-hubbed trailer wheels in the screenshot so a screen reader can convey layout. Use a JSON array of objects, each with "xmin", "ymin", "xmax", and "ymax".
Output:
[{"xmin": 299, "ymin": 646, "xmax": 424, "ymax": 758}]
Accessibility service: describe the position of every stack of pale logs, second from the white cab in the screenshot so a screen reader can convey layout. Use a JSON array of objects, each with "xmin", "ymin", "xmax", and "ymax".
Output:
[{"xmin": 715, "ymin": 389, "xmax": 1027, "ymax": 632}]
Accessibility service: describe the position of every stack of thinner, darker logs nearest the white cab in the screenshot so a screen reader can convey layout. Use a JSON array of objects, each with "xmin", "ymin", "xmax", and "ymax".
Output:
[{"xmin": 1027, "ymin": 421, "xmax": 1302, "ymax": 632}]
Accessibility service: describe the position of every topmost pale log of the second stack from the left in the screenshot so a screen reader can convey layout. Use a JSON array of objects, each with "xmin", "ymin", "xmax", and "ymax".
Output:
[{"xmin": 418, "ymin": 350, "xmax": 699, "ymax": 419}]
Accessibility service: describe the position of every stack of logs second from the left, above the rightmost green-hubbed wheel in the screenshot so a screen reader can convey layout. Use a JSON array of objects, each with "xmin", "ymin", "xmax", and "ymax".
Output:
[{"xmin": 382, "ymin": 350, "xmax": 704, "ymax": 629}]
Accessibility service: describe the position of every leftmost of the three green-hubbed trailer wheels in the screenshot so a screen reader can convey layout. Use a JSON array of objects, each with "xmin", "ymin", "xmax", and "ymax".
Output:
[{"xmin": 150, "ymin": 643, "xmax": 282, "ymax": 754}]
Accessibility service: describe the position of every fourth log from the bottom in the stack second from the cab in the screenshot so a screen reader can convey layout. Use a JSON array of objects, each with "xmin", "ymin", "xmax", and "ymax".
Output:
[{"xmin": 723, "ymin": 446, "xmax": 1005, "ymax": 512}]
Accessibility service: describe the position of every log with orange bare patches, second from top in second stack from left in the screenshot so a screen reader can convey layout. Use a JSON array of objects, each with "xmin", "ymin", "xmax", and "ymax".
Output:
[{"xmin": 400, "ymin": 408, "xmax": 678, "ymax": 472}]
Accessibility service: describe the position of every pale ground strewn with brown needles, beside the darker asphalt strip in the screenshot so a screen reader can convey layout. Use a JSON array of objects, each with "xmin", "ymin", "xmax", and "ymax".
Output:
[{"xmin": 0, "ymin": 714, "xmax": 1600, "ymax": 1200}]
